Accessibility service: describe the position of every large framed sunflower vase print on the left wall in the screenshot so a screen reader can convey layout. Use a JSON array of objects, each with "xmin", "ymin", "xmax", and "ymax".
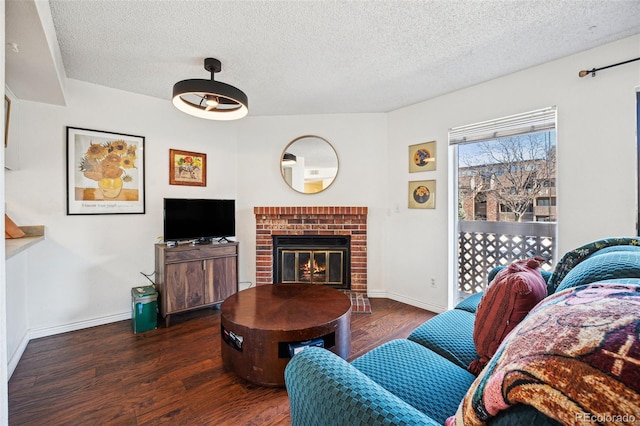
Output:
[{"xmin": 67, "ymin": 127, "xmax": 145, "ymax": 215}]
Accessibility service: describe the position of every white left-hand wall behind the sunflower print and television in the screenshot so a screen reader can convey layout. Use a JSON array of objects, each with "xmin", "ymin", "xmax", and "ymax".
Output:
[{"xmin": 5, "ymin": 80, "xmax": 237, "ymax": 340}]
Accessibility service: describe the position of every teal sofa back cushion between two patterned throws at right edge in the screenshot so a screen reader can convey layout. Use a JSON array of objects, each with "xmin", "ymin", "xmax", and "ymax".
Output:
[{"xmin": 556, "ymin": 249, "xmax": 640, "ymax": 292}]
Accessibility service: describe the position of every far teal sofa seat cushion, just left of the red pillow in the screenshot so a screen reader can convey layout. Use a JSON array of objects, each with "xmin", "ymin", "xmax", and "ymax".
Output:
[{"xmin": 407, "ymin": 309, "xmax": 478, "ymax": 369}]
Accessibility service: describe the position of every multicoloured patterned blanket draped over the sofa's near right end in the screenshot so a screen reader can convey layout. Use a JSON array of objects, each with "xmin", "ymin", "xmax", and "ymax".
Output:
[{"xmin": 446, "ymin": 284, "xmax": 640, "ymax": 426}]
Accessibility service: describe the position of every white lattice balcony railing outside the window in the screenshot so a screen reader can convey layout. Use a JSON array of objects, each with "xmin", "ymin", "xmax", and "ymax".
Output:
[{"xmin": 458, "ymin": 221, "xmax": 556, "ymax": 294}]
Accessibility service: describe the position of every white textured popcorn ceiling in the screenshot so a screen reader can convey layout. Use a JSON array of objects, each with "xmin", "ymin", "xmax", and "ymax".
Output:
[{"xmin": 13, "ymin": 0, "xmax": 640, "ymax": 116}]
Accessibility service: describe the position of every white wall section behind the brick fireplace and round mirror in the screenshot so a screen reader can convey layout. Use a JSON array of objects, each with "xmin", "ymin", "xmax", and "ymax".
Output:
[{"xmin": 238, "ymin": 114, "xmax": 387, "ymax": 294}]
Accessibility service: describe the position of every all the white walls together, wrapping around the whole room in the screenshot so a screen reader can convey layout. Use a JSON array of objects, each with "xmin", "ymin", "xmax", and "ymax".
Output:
[{"xmin": 5, "ymin": 36, "xmax": 640, "ymax": 386}]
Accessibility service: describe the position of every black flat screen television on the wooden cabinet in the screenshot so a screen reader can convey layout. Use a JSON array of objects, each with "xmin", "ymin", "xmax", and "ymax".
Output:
[{"xmin": 164, "ymin": 198, "xmax": 236, "ymax": 241}]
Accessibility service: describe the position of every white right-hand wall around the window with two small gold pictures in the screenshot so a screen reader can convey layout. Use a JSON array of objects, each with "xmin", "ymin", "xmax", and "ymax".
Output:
[{"xmin": 384, "ymin": 36, "xmax": 640, "ymax": 310}]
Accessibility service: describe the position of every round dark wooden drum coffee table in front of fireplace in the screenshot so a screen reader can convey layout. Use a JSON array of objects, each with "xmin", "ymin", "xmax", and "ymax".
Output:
[{"xmin": 221, "ymin": 284, "xmax": 351, "ymax": 386}]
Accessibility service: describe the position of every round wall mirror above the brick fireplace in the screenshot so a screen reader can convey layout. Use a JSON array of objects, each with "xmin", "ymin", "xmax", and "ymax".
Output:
[{"xmin": 280, "ymin": 135, "xmax": 338, "ymax": 194}]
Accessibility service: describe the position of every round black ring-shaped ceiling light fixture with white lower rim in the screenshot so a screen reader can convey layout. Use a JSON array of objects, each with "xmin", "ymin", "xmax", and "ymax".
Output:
[{"xmin": 173, "ymin": 58, "xmax": 249, "ymax": 120}]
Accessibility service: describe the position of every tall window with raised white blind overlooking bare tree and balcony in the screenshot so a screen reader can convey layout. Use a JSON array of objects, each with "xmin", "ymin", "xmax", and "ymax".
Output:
[{"xmin": 449, "ymin": 108, "xmax": 557, "ymax": 300}]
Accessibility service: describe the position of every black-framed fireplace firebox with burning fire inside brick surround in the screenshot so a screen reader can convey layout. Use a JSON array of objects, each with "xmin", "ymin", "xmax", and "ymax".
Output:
[{"xmin": 273, "ymin": 235, "xmax": 351, "ymax": 290}]
